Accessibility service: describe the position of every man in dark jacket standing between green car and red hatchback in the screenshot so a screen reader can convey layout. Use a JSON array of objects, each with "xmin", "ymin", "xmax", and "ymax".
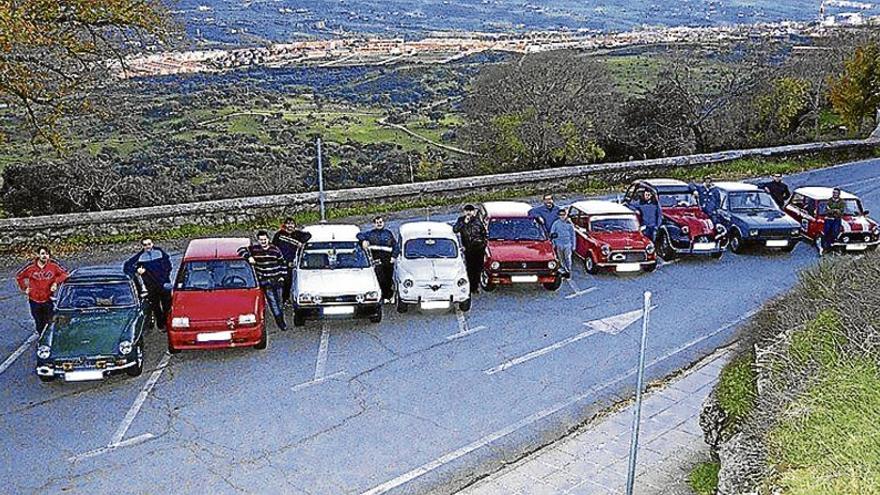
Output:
[{"xmin": 122, "ymin": 237, "xmax": 171, "ymax": 330}]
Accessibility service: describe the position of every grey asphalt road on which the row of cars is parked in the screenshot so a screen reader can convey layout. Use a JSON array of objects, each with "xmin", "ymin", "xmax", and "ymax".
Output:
[{"xmin": 0, "ymin": 160, "xmax": 880, "ymax": 494}]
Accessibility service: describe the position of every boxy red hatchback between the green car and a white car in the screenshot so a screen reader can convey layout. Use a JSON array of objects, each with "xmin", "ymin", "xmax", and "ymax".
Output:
[{"xmin": 166, "ymin": 238, "xmax": 267, "ymax": 353}]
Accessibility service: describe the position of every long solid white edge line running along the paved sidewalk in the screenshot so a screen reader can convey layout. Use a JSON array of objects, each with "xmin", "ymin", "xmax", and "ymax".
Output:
[{"xmin": 361, "ymin": 310, "xmax": 758, "ymax": 495}]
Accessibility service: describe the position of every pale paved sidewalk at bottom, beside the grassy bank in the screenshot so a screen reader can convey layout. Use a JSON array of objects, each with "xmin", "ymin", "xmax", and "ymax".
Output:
[{"xmin": 458, "ymin": 350, "xmax": 730, "ymax": 495}]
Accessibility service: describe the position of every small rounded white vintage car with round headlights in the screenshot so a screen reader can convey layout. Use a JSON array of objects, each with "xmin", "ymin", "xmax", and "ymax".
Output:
[{"xmin": 394, "ymin": 222, "xmax": 471, "ymax": 313}]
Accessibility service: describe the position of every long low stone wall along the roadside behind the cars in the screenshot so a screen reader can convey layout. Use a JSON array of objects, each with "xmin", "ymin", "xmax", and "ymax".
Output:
[{"xmin": 0, "ymin": 138, "xmax": 880, "ymax": 251}]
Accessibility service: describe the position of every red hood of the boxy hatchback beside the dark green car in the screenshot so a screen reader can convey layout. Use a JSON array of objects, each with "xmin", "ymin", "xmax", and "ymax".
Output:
[{"xmin": 171, "ymin": 289, "xmax": 262, "ymax": 322}]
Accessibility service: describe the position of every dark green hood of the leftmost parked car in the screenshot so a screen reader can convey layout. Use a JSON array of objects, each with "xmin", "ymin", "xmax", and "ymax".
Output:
[{"xmin": 40, "ymin": 307, "xmax": 139, "ymax": 358}]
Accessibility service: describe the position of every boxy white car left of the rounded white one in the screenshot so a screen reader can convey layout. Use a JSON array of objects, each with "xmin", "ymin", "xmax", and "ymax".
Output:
[{"xmin": 292, "ymin": 225, "xmax": 382, "ymax": 326}]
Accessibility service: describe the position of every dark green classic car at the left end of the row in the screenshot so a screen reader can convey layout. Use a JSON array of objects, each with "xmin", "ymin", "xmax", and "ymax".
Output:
[{"xmin": 36, "ymin": 267, "xmax": 149, "ymax": 382}]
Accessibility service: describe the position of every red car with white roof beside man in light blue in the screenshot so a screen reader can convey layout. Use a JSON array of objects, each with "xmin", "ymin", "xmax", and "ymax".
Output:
[{"xmin": 568, "ymin": 201, "xmax": 657, "ymax": 274}]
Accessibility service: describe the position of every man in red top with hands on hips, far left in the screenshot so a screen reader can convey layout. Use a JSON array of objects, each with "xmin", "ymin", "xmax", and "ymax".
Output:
[{"xmin": 15, "ymin": 246, "xmax": 69, "ymax": 333}]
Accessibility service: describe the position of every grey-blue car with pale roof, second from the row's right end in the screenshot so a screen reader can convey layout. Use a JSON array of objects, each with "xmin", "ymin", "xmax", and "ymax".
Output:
[{"xmin": 715, "ymin": 182, "xmax": 801, "ymax": 253}]
